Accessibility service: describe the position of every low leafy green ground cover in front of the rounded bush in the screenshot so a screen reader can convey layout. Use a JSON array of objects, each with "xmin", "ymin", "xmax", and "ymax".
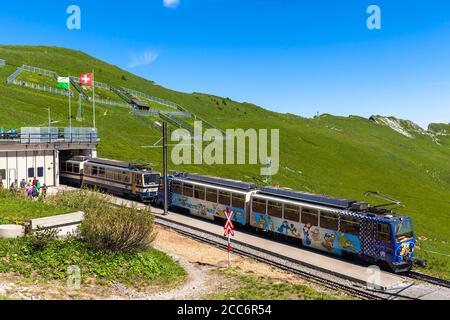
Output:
[{"xmin": 0, "ymin": 236, "xmax": 186, "ymax": 284}]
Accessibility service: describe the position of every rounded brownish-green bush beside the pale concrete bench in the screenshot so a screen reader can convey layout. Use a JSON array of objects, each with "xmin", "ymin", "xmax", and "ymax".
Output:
[{"xmin": 80, "ymin": 206, "xmax": 155, "ymax": 252}]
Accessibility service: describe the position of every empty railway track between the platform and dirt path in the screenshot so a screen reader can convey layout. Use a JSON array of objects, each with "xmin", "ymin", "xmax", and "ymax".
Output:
[{"xmin": 155, "ymin": 215, "xmax": 411, "ymax": 300}]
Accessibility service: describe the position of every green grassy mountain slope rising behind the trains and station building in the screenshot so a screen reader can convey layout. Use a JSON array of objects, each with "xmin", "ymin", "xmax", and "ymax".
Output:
[{"xmin": 0, "ymin": 46, "xmax": 450, "ymax": 278}]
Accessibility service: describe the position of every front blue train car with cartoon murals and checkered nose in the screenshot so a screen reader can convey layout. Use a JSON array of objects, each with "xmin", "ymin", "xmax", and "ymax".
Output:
[{"xmin": 250, "ymin": 188, "xmax": 416, "ymax": 272}]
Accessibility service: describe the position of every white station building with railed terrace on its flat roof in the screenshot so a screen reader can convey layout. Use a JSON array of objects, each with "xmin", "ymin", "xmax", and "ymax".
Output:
[{"xmin": 0, "ymin": 128, "xmax": 99, "ymax": 188}]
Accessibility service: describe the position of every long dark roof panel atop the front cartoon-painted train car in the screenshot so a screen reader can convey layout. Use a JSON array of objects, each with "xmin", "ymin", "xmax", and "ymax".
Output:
[{"xmin": 260, "ymin": 187, "xmax": 356, "ymax": 209}]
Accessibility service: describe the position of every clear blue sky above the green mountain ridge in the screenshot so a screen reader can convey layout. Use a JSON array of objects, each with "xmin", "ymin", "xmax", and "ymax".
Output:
[{"xmin": 0, "ymin": 0, "xmax": 450, "ymax": 126}]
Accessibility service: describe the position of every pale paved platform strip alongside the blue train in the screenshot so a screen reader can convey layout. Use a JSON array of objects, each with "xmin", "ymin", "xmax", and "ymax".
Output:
[{"xmin": 152, "ymin": 208, "xmax": 411, "ymax": 291}]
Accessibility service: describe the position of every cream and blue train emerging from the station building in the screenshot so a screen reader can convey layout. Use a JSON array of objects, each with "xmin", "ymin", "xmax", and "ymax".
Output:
[{"xmin": 60, "ymin": 156, "xmax": 161, "ymax": 203}]
